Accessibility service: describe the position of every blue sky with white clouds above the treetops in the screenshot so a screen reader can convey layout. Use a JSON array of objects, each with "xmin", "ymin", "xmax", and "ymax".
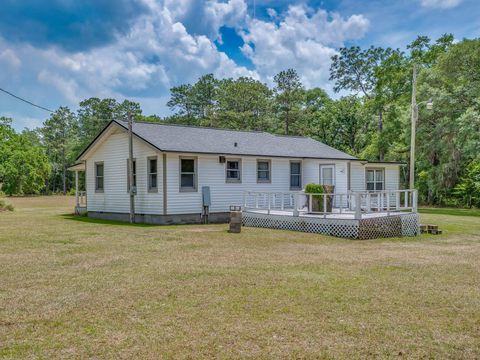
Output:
[{"xmin": 0, "ymin": 0, "xmax": 480, "ymax": 130}]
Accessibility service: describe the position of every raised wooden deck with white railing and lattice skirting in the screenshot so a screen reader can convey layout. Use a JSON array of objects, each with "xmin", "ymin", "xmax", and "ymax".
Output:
[{"xmin": 242, "ymin": 190, "xmax": 419, "ymax": 239}]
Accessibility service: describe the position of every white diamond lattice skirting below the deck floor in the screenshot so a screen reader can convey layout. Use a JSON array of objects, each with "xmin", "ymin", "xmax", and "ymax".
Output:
[{"xmin": 242, "ymin": 212, "xmax": 418, "ymax": 239}]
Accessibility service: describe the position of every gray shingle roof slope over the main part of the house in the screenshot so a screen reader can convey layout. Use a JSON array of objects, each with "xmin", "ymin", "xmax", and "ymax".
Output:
[{"xmin": 116, "ymin": 121, "xmax": 356, "ymax": 159}]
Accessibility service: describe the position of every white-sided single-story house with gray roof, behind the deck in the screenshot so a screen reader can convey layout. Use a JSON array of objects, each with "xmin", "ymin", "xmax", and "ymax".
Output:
[{"xmin": 70, "ymin": 121, "xmax": 401, "ymax": 224}]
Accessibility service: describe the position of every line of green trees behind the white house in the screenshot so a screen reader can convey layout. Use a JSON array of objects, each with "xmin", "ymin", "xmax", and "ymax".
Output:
[{"xmin": 0, "ymin": 34, "xmax": 480, "ymax": 206}]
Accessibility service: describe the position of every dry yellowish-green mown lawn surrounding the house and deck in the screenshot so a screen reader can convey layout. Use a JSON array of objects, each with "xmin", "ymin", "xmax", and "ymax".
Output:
[{"xmin": 0, "ymin": 197, "xmax": 480, "ymax": 359}]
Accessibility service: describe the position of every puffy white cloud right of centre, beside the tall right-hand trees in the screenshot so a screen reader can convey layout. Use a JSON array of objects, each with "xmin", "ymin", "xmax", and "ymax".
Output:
[{"xmin": 241, "ymin": 5, "xmax": 369, "ymax": 88}]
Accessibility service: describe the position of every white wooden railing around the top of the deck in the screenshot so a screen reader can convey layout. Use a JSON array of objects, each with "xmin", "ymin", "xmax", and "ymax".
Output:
[{"xmin": 243, "ymin": 189, "xmax": 417, "ymax": 219}]
